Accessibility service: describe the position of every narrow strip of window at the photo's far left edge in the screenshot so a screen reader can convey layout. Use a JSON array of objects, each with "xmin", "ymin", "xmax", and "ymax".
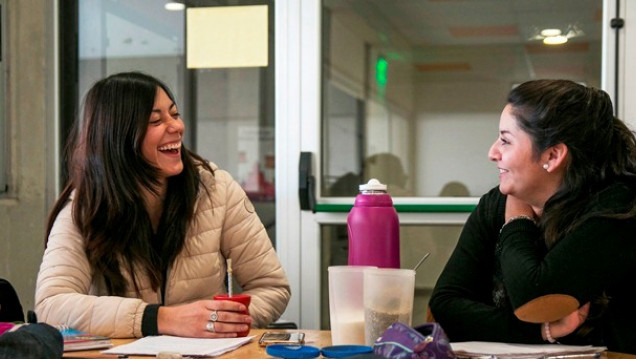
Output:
[{"xmin": 0, "ymin": 0, "xmax": 9, "ymax": 194}]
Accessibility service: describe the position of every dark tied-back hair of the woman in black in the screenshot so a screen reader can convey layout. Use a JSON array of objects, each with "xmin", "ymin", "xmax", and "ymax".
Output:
[{"xmin": 508, "ymin": 80, "xmax": 636, "ymax": 247}]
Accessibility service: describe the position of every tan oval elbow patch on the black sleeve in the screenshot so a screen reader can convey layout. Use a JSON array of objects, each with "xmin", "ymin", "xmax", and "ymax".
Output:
[{"xmin": 515, "ymin": 294, "xmax": 579, "ymax": 323}]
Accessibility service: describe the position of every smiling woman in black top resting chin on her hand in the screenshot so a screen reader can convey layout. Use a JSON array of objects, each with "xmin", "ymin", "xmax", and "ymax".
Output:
[{"xmin": 430, "ymin": 80, "xmax": 636, "ymax": 354}]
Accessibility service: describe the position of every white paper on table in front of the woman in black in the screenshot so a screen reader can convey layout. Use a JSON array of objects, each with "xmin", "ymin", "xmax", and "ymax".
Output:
[{"xmin": 451, "ymin": 342, "xmax": 607, "ymax": 358}]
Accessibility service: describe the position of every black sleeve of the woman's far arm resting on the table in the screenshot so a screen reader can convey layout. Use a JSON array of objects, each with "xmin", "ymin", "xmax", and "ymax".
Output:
[{"xmin": 430, "ymin": 188, "xmax": 543, "ymax": 343}]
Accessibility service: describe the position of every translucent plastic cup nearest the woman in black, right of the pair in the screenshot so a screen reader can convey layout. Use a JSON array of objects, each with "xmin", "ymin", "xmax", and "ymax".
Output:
[{"xmin": 364, "ymin": 268, "xmax": 415, "ymax": 346}]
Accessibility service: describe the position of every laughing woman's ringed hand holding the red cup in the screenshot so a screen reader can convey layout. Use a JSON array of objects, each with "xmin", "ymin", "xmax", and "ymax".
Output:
[{"xmin": 157, "ymin": 300, "xmax": 252, "ymax": 338}]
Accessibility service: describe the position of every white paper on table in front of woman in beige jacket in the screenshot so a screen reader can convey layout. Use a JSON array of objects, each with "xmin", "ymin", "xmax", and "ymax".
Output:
[{"xmin": 102, "ymin": 335, "xmax": 254, "ymax": 356}]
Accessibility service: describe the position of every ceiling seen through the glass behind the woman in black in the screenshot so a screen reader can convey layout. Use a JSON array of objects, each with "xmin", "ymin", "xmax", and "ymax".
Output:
[{"xmin": 324, "ymin": 0, "xmax": 603, "ymax": 81}]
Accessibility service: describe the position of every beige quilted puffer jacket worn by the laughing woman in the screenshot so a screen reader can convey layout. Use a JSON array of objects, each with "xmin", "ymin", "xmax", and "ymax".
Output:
[{"xmin": 35, "ymin": 164, "xmax": 290, "ymax": 338}]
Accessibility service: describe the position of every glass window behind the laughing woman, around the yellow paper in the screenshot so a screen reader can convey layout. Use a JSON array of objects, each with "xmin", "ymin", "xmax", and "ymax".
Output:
[{"xmin": 69, "ymin": 0, "xmax": 275, "ymax": 245}]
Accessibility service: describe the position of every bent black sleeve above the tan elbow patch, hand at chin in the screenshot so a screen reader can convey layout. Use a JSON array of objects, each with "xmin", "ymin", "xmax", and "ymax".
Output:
[{"xmin": 501, "ymin": 214, "xmax": 636, "ymax": 308}]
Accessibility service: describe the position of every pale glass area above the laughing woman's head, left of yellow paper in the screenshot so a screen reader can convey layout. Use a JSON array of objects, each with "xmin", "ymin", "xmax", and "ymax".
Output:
[{"xmin": 78, "ymin": 0, "xmax": 190, "ymax": 119}]
